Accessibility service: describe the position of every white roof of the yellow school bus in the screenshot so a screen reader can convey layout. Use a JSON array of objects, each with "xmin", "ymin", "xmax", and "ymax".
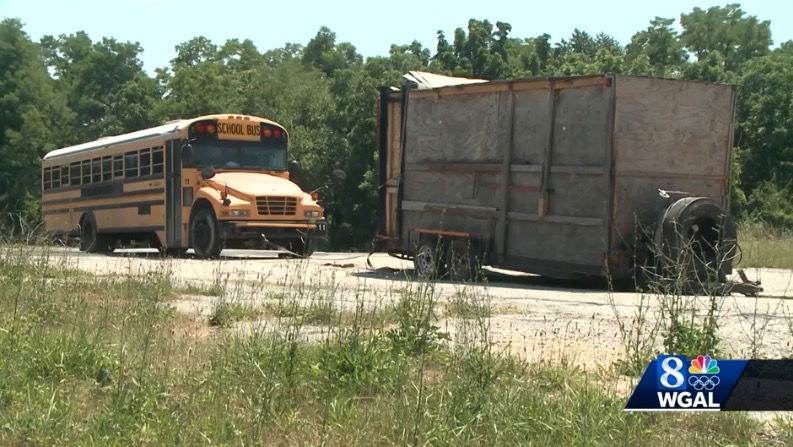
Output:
[{"xmin": 44, "ymin": 114, "xmax": 283, "ymax": 160}]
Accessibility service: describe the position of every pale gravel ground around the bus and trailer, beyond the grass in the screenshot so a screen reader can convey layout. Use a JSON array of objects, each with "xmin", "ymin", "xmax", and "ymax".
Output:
[{"xmin": 40, "ymin": 249, "xmax": 793, "ymax": 369}]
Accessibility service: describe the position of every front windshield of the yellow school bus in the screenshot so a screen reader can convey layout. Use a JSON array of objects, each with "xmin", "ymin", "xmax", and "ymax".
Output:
[{"xmin": 189, "ymin": 140, "xmax": 286, "ymax": 171}]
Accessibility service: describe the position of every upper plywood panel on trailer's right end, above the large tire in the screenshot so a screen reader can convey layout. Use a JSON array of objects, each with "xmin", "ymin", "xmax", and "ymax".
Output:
[{"xmin": 614, "ymin": 76, "xmax": 734, "ymax": 176}]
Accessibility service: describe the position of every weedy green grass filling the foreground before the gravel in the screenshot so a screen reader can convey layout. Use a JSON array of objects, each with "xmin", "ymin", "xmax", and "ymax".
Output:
[{"xmin": 0, "ymin": 249, "xmax": 793, "ymax": 446}]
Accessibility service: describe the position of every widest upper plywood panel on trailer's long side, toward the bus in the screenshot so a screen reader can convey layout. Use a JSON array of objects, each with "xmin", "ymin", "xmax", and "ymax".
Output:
[{"xmin": 405, "ymin": 93, "xmax": 500, "ymax": 163}]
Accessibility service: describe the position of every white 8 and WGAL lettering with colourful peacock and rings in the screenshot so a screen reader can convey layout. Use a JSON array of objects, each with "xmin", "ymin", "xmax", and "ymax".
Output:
[{"xmin": 656, "ymin": 355, "xmax": 720, "ymax": 409}]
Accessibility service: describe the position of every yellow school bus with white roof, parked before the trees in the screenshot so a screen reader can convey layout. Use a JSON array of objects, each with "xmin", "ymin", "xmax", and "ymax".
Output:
[{"xmin": 41, "ymin": 115, "xmax": 327, "ymax": 258}]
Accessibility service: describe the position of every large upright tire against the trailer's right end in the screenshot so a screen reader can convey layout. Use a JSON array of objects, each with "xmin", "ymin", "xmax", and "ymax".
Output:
[{"xmin": 654, "ymin": 197, "xmax": 737, "ymax": 284}]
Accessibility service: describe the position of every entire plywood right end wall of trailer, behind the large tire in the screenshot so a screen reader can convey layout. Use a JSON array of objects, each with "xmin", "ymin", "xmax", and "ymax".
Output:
[{"xmin": 612, "ymin": 76, "xmax": 735, "ymax": 254}]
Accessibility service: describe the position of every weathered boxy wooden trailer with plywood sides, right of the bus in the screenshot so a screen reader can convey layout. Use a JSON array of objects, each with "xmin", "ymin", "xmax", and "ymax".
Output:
[{"xmin": 376, "ymin": 74, "xmax": 736, "ymax": 280}]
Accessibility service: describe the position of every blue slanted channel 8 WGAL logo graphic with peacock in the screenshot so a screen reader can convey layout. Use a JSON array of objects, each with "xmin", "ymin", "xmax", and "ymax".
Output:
[{"xmin": 625, "ymin": 355, "xmax": 746, "ymax": 411}]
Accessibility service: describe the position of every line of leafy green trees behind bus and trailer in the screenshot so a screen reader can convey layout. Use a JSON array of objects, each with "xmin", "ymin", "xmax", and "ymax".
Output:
[{"xmin": 0, "ymin": 4, "xmax": 793, "ymax": 249}]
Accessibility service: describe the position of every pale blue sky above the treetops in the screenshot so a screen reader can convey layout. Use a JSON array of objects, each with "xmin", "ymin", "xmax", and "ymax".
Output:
[{"xmin": 0, "ymin": 0, "xmax": 793, "ymax": 73}]
